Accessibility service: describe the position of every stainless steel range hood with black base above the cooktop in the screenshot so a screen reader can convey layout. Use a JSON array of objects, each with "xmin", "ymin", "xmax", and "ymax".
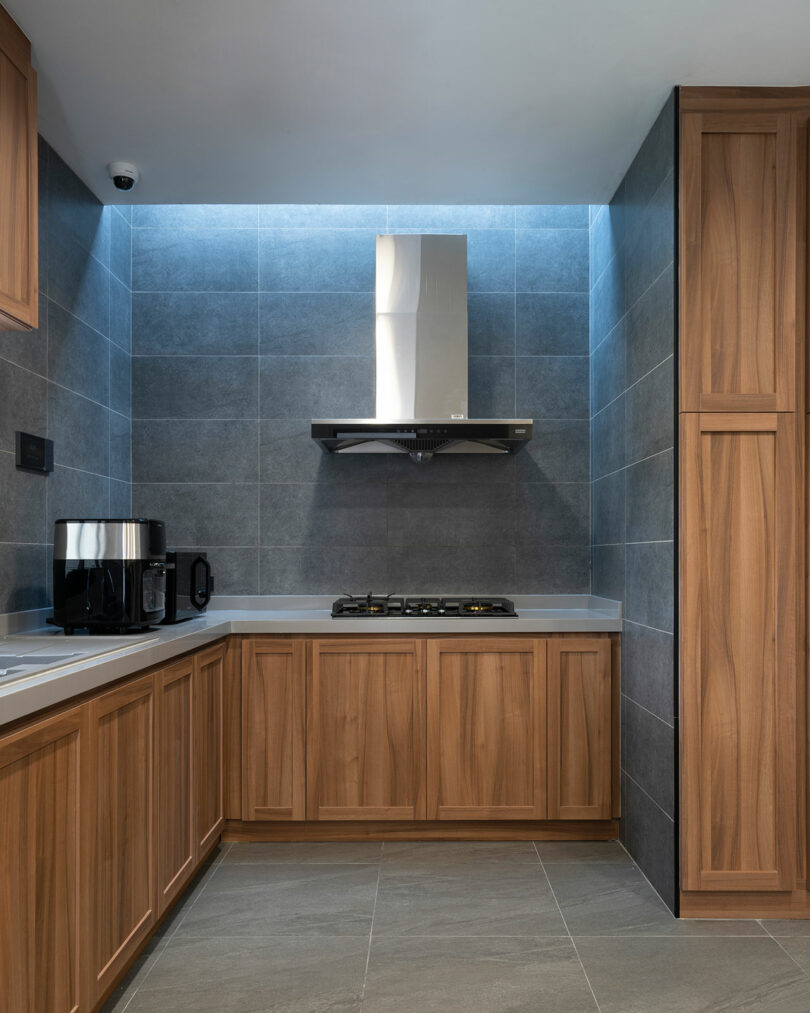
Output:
[{"xmin": 312, "ymin": 235, "xmax": 532, "ymax": 462}]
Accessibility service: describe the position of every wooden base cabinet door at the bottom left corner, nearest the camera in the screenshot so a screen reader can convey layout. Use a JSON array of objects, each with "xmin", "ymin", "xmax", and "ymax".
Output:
[{"xmin": 0, "ymin": 708, "xmax": 84, "ymax": 1013}]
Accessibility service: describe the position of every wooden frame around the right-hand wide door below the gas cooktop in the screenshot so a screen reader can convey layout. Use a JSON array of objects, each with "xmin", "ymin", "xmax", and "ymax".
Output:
[{"xmin": 427, "ymin": 634, "xmax": 548, "ymax": 820}]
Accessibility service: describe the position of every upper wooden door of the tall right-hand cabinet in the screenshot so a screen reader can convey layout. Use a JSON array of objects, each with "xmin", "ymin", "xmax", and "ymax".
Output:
[{"xmin": 680, "ymin": 112, "xmax": 804, "ymax": 411}]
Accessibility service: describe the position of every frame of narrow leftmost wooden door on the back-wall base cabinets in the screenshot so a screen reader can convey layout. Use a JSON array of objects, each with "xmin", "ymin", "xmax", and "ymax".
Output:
[{"xmin": 241, "ymin": 635, "xmax": 307, "ymax": 822}]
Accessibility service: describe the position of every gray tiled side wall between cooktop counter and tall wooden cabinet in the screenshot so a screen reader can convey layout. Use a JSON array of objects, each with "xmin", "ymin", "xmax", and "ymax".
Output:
[{"xmin": 590, "ymin": 96, "xmax": 677, "ymax": 907}]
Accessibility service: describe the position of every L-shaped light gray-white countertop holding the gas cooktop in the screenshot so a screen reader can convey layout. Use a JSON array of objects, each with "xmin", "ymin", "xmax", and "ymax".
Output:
[{"xmin": 0, "ymin": 595, "xmax": 622, "ymax": 725}]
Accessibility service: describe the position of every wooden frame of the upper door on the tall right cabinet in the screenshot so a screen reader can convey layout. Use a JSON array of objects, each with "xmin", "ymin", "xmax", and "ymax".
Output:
[{"xmin": 679, "ymin": 110, "xmax": 804, "ymax": 412}]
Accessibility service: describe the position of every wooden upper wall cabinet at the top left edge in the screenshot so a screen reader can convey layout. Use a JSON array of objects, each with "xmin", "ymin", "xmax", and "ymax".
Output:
[{"xmin": 0, "ymin": 7, "xmax": 38, "ymax": 330}]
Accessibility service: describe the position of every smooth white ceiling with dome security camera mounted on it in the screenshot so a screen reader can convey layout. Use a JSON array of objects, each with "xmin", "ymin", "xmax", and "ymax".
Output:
[{"xmin": 9, "ymin": 0, "xmax": 810, "ymax": 204}]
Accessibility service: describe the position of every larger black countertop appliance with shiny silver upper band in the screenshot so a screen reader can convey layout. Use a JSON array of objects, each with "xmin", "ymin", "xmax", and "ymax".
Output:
[{"xmin": 50, "ymin": 518, "xmax": 166, "ymax": 634}]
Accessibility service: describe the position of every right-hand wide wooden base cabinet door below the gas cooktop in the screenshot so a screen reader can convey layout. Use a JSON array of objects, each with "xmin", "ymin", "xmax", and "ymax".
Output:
[{"xmin": 427, "ymin": 636, "xmax": 547, "ymax": 820}]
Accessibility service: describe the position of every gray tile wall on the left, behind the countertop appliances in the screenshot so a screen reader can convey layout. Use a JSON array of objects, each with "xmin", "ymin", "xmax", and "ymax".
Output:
[{"xmin": 0, "ymin": 139, "xmax": 132, "ymax": 613}]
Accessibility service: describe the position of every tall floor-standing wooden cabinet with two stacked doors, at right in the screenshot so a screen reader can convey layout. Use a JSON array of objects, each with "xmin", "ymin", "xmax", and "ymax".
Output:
[{"xmin": 679, "ymin": 88, "xmax": 810, "ymax": 917}]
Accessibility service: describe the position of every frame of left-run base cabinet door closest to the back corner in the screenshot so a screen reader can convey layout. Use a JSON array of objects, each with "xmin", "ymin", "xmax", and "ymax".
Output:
[{"xmin": 191, "ymin": 644, "xmax": 225, "ymax": 864}]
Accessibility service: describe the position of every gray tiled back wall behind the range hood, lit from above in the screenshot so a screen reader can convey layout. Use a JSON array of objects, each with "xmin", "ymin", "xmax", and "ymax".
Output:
[{"xmin": 132, "ymin": 206, "xmax": 590, "ymax": 594}]
